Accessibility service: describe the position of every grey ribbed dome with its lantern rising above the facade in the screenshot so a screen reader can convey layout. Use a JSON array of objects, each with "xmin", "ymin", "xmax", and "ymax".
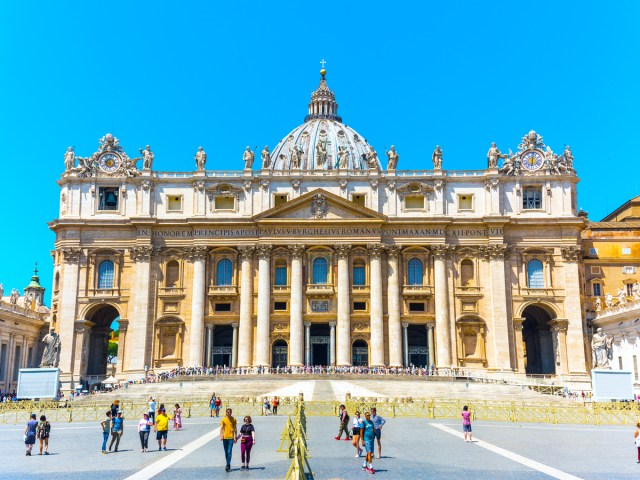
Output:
[{"xmin": 269, "ymin": 69, "xmax": 381, "ymax": 172}]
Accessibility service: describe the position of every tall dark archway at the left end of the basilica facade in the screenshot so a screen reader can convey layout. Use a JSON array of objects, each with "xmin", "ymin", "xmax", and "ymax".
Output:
[{"xmin": 83, "ymin": 305, "xmax": 120, "ymax": 376}]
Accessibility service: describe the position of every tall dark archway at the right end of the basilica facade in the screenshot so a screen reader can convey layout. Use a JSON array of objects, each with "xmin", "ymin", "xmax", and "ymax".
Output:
[{"xmin": 522, "ymin": 305, "xmax": 556, "ymax": 375}]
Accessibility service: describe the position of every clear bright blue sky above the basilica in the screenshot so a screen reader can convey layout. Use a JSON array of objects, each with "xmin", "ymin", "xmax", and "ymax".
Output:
[{"xmin": 0, "ymin": 1, "xmax": 640, "ymax": 298}]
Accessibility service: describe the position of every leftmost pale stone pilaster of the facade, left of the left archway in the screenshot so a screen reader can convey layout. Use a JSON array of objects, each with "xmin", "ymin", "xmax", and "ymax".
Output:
[{"xmin": 57, "ymin": 247, "xmax": 82, "ymax": 378}]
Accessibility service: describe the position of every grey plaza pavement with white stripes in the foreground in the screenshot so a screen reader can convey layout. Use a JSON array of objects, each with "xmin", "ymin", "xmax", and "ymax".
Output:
[{"xmin": 0, "ymin": 411, "xmax": 640, "ymax": 480}]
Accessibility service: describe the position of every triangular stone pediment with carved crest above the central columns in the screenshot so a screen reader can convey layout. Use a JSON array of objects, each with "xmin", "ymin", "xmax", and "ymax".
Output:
[{"xmin": 254, "ymin": 188, "xmax": 387, "ymax": 222}]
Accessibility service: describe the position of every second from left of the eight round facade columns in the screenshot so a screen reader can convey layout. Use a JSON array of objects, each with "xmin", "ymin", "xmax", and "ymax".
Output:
[{"xmin": 236, "ymin": 246, "xmax": 254, "ymax": 367}]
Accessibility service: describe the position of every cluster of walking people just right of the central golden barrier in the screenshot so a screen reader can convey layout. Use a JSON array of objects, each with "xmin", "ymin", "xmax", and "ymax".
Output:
[{"xmin": 335, "ymin": 405, "xmax": 387, "ymax": 473}]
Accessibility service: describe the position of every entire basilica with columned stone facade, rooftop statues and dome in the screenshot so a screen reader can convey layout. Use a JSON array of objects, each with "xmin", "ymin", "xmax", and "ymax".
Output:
[{"xmin": 50, "ymin": 71, "xmax": 586, "ymax": 385}]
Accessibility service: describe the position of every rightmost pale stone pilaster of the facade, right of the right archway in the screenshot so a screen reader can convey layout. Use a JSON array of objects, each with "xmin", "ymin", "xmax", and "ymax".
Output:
[{"xmin": 561, "ymin": 246, "xmax": 587, "ymax": 374}]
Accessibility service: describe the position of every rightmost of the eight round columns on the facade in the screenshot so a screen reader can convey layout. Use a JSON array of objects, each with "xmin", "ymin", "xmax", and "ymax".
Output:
[{"xmin": 431, "ymin": 245, "xmax": 451, "ymax": 368}]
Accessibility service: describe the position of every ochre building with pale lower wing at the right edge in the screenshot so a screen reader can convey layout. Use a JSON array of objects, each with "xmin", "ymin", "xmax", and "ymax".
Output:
[{"xmin": 582, "ymin": 196, "xmax": 640, "ymax": 393}]
